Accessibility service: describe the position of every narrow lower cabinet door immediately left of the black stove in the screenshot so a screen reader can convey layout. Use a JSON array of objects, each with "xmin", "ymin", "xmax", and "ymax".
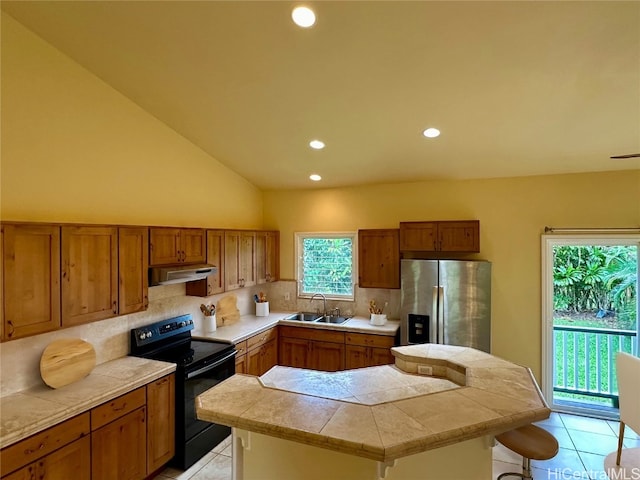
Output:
[{"xmin": 147, "ymin": 374, "xmax": 175, "ymax": 473}]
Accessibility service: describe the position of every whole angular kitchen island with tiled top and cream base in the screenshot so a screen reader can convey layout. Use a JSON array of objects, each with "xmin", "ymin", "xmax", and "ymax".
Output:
[{"xmin": 196, "ymin": 344, "xmax": 550, "ymax": 480}]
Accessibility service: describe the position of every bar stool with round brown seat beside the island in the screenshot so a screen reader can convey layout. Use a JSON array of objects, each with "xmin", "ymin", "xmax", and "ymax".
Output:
[{"xmin": 496, "ymin": 425, "xmax": 558, "ymax": 480}]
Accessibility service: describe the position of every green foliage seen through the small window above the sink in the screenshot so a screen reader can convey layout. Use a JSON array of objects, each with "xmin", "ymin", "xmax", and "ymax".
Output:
[{"xmin": 301, "ymin": 237, "xmax": 353, "ymax": 296}]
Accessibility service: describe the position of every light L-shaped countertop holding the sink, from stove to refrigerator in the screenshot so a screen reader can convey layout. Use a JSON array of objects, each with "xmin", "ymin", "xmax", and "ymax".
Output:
[{"xmin": 191, "ymin": 312, "xmax": 400, "ymax": 343}]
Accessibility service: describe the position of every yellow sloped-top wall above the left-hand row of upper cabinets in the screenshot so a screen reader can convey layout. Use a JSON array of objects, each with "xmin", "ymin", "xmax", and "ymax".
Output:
[{"xmin": 0, "ymin": 13, "xmax": 262, "ymax": 228}]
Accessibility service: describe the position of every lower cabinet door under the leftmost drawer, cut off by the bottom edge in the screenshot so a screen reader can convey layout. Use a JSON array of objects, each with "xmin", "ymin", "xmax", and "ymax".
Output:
[{"xmin": 37, "ymin": 436, "xmax": 91, "ymax": 480}]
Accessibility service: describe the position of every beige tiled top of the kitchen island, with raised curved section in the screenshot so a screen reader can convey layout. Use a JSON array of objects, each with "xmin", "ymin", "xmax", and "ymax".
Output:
[{"xmin": 196, "ymin": 344, "xmax": 551, "ymax": 462}]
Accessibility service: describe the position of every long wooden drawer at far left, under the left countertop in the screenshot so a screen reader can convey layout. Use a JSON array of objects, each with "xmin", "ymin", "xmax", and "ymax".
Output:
[{"xmin": 0, "ymin": 413, "xmax": 89, "ymax": 476}]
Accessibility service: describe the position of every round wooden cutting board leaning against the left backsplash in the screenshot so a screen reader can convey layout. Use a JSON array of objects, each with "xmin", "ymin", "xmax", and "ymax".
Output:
[{"xmin": 40, "ymin": 338, "xmax": 96, "ymax": 388}]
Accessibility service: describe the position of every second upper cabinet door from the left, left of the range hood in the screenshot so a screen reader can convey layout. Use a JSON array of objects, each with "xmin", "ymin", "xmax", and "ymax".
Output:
[{"xmin": 62, "ymin": 226, "xmax": 118, "ymax": 327}]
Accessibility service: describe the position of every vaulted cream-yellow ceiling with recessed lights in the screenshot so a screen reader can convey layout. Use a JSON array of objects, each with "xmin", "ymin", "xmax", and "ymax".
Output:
[{"xmin": 2, "ymin": 0, "xmax": 640, "ymax": 189}]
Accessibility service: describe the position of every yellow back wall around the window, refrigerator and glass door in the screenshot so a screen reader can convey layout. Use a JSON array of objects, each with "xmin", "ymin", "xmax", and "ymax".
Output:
[{"xmin": 265, "ymin": 170, "xmax": 640, "ymax": 379}]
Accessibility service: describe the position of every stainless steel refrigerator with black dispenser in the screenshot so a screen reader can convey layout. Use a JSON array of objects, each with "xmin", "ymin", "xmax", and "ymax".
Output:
[{"xmin": 400, "ymin": 260, "xmax": 491, "ymax": 352}]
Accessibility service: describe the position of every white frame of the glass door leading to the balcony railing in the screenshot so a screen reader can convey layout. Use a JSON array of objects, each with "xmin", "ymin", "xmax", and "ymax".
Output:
[{"xmin": 540, "ymin": 233, "xmax": 640, "ymax": 418}]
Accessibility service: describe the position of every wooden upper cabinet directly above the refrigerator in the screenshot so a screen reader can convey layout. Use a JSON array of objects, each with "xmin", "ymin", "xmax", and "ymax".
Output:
[{"xmin": 400, "ymin": 220, "xmax": 480, "ymax": 253}]
